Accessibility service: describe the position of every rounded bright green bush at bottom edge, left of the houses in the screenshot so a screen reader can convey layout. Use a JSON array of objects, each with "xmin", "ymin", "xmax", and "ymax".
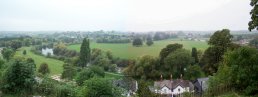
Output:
[{"xmin": 77, "ymin": 77, "xmax": 122, "ymax": 97}]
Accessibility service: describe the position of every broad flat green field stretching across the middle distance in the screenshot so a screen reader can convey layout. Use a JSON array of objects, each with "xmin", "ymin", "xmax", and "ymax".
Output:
[{"xmin": 68, "ymin": 40, "xmax": 208, "ymax": 59}]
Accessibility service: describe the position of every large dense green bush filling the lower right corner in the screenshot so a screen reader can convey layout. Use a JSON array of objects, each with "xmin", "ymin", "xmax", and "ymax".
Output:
[{"xmin": 209, "ymin": 47, "xmax": 258, "ymax": 95}]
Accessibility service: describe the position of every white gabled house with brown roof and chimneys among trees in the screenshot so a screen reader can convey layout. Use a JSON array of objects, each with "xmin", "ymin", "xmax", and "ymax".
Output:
[{"xmin": 150, "ymin": 77, "xmax": 194, "ymax": 95}]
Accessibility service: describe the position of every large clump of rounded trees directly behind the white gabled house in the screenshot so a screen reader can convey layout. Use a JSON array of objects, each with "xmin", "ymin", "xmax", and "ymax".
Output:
[{"xmin": 124, "ymin": 44, "xmax": 204, "ymax": 80}]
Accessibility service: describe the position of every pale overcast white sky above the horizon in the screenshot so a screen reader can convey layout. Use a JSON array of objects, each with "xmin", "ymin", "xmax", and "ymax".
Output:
[{"xmin": 0, "ymin": 0, "xmax": 251, "ymax": 31}]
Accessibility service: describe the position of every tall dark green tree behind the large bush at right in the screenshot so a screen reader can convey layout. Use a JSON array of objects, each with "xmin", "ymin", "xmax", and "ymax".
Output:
[{"xmin": 200, "ymin": 29, "xmax": 233, "ymax": 75}]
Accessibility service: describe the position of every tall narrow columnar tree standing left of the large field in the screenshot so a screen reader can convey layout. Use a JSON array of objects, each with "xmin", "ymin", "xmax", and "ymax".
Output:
[{"xmin": 80, "ymin": 38, "xmax": 90, "ymax": 67}]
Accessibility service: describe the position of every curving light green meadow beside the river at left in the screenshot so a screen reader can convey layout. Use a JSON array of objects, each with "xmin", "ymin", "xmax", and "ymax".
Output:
[{"xmin": 15, "ymin": 47, "xmax": 64, "ymax": 75}]
